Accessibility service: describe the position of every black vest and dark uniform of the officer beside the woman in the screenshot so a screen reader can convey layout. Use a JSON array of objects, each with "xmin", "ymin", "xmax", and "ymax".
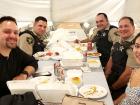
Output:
[{"xmin": 107, "ymin": 35, "xmax": 134, "ymax": 99}]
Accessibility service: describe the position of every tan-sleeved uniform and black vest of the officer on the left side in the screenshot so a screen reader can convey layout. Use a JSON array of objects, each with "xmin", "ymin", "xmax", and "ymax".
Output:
[{"xmin": 18, "ymin": 30, "xmax": 46, "ymax": 55}]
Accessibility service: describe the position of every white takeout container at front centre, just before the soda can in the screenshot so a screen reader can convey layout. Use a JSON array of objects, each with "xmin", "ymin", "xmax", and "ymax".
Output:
[{"xmin": 37, "ymin": 82, "xmax": 78, "ymax": 103}]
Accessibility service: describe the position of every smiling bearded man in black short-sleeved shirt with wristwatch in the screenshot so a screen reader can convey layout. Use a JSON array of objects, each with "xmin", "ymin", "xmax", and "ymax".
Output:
[{"xmin": 0, "ymin": 16, "xmax": 38, "ymax": 97}]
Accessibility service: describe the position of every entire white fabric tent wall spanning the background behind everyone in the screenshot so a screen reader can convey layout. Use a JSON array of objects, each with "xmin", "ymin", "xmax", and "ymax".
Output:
[{"xmin": 0, "ymin": 0, "xmax": 140, "ymax": 27}]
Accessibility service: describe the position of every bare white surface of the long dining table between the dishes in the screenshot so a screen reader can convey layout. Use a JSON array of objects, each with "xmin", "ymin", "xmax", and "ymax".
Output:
[{"xmin": 38, "ymin": 54, "xmax": 114, "ymax": 105}]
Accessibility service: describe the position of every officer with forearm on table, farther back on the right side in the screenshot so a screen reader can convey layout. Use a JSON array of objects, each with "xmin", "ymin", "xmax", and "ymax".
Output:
[{"xmin": 81, "ymin": 13, "xmax": 119, "ymax": 67}]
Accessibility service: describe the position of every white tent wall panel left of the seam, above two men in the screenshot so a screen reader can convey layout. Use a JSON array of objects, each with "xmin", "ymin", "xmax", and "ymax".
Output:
[{"xmin": 0, "ymin": 0, "xmax": 51, "ymax": 22}]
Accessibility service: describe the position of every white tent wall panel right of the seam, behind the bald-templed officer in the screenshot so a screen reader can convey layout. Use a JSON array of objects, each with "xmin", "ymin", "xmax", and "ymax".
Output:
[{"xmin": 52, "ymin": 0, "xmax": 126, "ymax": 22}]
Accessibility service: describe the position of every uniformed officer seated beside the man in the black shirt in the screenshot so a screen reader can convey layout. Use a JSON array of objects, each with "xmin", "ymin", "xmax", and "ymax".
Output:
[{"xmin": 18, "ymin": 16, "xmax": 47, "ymax": 55}]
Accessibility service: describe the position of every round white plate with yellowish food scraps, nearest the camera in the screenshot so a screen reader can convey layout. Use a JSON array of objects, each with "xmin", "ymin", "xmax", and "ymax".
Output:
[{"xmin": 79, "ymin": 85, "xmax": 107, "ymax": 98}]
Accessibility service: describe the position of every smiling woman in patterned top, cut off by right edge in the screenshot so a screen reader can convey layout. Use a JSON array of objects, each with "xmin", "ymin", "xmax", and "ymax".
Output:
[{"xmin": 114, "ymin": 33, "xmax": 140, "ymax": 105}]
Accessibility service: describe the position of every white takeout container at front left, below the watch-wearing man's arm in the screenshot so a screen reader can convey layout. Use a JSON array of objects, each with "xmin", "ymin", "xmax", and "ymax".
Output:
[{"xmin": 7, "ymin": 76, "xmax": 53, "ymax": 99}]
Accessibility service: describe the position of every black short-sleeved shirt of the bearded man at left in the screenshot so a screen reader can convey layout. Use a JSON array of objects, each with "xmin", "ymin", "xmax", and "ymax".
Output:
[{"xmin": 0, "ymin": 47, "xmax": 38, "ymax": 97}]
